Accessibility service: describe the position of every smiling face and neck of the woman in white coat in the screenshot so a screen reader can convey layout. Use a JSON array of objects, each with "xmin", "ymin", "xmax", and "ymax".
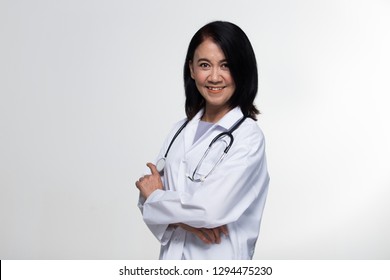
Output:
[{"xmin": 190, "ymin": 39, "xmax": 236, "ymax": 115}]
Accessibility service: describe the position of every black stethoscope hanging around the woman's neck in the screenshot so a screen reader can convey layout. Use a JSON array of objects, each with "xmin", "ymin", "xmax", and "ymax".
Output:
[{"xmin": 156, "ymin": 116, "xmax": 247, "ymax": 182}]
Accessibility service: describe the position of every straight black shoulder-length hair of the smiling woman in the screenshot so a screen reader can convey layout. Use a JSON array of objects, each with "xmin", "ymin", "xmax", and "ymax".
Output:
[{"xmin": 184, "ymin": 21, "xmax": 259, "ymax": 120}]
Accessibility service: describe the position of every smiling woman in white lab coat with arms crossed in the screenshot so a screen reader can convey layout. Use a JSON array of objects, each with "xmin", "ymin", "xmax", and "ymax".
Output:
[{"xmin": 136, "ymin": 21, "xmax": 269, "ymax": 259}]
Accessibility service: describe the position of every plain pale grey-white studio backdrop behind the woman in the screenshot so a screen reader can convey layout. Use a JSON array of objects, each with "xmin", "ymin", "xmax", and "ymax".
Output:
[{"xmin": 0, "ymin": 0, "xmax": 390, "ymax": 259}]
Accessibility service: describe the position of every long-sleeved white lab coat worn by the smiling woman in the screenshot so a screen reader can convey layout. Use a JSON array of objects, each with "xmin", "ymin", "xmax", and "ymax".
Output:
[{"xmin": 138, "ymin": 108, "xmax": 269, "ymax": 259}]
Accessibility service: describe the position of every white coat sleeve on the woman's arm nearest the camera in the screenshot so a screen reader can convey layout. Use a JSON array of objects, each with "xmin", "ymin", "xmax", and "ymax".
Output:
[{"xmin": 143, "ymin": 123, "xmax": 269, "ymax": 228}]
